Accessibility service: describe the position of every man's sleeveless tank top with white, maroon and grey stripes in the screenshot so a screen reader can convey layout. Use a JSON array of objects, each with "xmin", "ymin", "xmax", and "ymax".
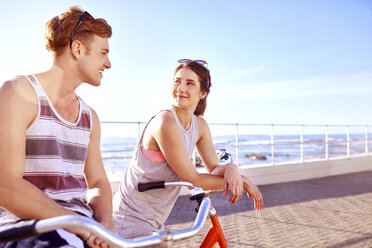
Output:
[{"xmin": 0, "ymin": 75, "xmax": 92, "ymax": 225}]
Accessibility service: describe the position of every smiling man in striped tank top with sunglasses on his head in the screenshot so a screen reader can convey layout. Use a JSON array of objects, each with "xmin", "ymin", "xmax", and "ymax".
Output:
[{"xmin": 0, "ymin": 7, "xmax": 114, "ymax": 247}]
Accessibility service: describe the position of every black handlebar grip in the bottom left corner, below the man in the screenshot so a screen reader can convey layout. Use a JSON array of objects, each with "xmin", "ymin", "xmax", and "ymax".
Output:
[{"xmin": 0, "ymin": 220, "xmax": 39, "ymax": 243}]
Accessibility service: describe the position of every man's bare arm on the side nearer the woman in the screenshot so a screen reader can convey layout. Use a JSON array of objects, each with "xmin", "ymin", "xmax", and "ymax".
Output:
[{"xmin": 84, "ymin": 110, "xmax": 114, "ymax": 230}]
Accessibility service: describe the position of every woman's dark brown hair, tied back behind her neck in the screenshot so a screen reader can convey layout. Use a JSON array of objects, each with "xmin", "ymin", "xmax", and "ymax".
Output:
[{"xmin": 174, "ymin": 60, "xmax": 212, "ymax": 116}]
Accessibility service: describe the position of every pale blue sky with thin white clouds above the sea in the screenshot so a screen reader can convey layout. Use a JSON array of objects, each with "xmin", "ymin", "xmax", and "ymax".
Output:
[{"xmin": 0, "ymin": 0, "xmax": 372, "ymax": 128}]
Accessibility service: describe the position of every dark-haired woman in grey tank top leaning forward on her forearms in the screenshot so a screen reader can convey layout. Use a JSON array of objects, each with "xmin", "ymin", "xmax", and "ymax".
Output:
[{"xmin": 113, "ymin": 60, "xmax": 263, "ymax": 238}]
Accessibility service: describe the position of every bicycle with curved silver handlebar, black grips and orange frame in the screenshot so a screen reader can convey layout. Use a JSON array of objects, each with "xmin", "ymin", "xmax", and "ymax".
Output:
[{"xmin": 0, "ymin": 181, "xmax": 227, "ymax": 248}]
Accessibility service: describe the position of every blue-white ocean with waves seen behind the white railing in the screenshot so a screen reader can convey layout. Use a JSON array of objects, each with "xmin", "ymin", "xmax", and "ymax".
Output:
[{"xmin": 101, "ymin": 133, "xmax": 372, "ymax": 181}]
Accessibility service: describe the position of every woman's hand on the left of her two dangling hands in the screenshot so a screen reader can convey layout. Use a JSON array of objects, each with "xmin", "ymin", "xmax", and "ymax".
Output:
[{"xmin": 223, "ymin": 164, "xmax": 243, "ymax": 205}]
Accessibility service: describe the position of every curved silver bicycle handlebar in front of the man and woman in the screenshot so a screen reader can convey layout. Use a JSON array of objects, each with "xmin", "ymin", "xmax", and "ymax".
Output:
[{"xmin": 0, "ymin": 182, "xmax": 211, "ymax": 248}]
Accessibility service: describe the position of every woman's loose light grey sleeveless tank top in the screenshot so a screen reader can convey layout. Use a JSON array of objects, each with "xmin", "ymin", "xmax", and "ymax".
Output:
[{"xmin": 114, "ymin": 109, "xmax": 198, "ymax": 238}]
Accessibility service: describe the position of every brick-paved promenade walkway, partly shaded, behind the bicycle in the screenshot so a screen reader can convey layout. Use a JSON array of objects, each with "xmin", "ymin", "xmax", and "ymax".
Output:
[{"xmin": 166, "ymin": 170, "xmax": 372, "ymax": 248}]
